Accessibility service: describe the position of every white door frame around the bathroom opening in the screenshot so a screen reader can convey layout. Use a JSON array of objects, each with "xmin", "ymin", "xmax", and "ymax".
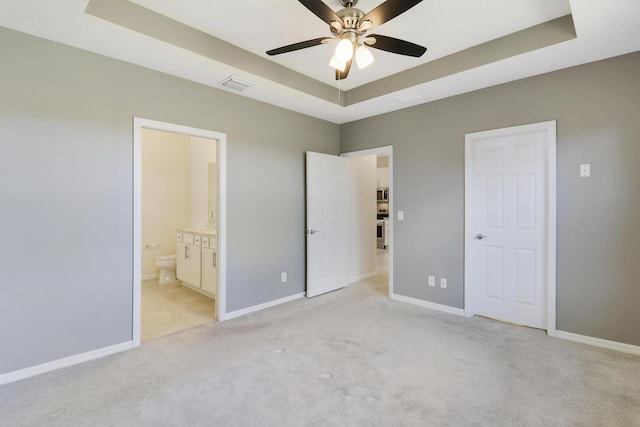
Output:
[{"xmin": 132, "ymin": 117, "xmax": 227, "ymax": 347}]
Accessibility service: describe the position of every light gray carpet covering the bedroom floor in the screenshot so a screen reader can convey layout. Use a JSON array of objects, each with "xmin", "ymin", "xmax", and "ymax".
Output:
[{"xmin": 0, "ymin": 279, "xmax": 640, "ymax": 426}]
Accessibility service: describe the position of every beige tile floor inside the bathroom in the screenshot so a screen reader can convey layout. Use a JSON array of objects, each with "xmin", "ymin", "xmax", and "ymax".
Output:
[{"xmin": 141, "ymin": 279, "xmax": 215, "ymax": 342}]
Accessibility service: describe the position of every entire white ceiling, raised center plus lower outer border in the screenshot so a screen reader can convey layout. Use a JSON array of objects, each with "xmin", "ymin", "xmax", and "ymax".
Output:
[{"xmin": 0, "ymin": 0, "xmax": 640, "ymax": 123}]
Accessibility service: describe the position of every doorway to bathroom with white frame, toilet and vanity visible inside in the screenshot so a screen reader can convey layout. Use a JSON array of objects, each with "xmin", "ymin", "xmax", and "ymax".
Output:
[{"xmin": 133, "ymin": 118, "xmax": 226, "ymax": 345}]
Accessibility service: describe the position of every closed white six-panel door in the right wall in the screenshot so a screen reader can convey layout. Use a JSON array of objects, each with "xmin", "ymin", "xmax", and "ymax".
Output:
[{"xmin": 467, "ymin": 125, "xmax": 555, "ymax": 329}]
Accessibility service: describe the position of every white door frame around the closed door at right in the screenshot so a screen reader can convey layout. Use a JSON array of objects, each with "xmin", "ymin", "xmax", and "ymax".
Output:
[{"xmin": 464, "ymin": 120, "xmax": 556, "ymax": 336}]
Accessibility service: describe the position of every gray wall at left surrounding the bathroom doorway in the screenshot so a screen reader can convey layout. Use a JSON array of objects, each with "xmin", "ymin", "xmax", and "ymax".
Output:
[{"xmin": 0, "ymin": 28, "xmax": 339, "ymax": 374}]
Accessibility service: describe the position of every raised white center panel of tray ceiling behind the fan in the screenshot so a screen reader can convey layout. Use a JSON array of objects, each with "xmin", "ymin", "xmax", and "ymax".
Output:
[{"xmin": 131, "ymin": 0, "xmax": 571, "ymax": 89}]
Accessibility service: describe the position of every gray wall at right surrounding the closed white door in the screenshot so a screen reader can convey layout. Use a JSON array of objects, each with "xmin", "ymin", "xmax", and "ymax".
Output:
[{"xmin": 341, "ymin": 53, "xmax": 640, "ymax": 345}]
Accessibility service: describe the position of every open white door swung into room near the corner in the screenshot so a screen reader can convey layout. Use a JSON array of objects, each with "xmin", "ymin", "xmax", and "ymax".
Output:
[{"xmin": 306, "ymin": 152, "xmax": 348, "ymax": 297}]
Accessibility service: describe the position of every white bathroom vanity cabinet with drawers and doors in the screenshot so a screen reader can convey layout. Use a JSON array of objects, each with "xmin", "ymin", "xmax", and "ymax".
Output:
[{"xmin": 176, "ymin": 229, "xmax": 218, "ymax": 298}]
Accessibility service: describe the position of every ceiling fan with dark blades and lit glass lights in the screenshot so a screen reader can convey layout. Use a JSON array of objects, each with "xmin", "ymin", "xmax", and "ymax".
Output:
[{"xmin": 266, "ymin": 0, "xmax": 427, "ymax": 80}]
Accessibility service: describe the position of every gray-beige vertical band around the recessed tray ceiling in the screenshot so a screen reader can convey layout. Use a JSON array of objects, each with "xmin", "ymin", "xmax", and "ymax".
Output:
[{"xmin": 85, "ymin": 0, "xmax": 576, "ymax": 107}]
